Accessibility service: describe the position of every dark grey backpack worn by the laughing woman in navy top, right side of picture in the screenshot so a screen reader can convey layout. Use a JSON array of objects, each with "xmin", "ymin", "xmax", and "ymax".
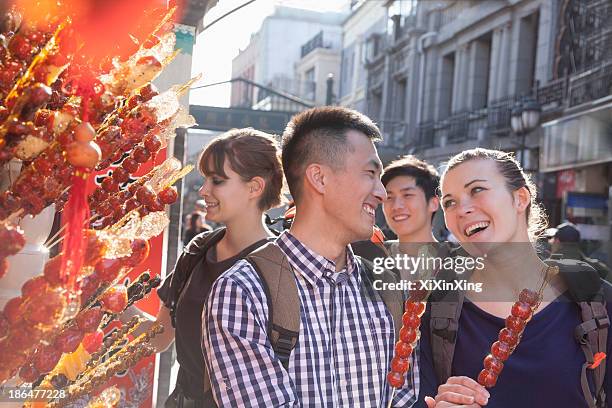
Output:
[{"xmin": 430, "ymin": 257, "xmax": 612, "ymax": 408}]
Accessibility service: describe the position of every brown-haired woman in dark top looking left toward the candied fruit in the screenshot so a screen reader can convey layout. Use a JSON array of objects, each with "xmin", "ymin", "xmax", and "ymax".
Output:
[{"xmin": 122, "ymin": 128, "xmax": 283, "ymax": 408}]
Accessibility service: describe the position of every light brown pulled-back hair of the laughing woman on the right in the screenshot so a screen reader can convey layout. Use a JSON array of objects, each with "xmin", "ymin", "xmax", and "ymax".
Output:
[{"xmin": 442, "ymin": 147, "xmax": 548, "ymax": 241}]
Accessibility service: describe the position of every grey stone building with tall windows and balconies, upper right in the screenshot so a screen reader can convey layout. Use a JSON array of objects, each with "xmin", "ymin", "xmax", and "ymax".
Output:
[{"xmin": 358, "ymin": 0, "xmax": 612, "ymax": 252}]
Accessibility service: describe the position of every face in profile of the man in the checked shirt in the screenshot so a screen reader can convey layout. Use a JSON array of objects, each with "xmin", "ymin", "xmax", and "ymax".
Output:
[{"xmin": 323, "ymin": 130, "xmax": 386, "ymax": 244}]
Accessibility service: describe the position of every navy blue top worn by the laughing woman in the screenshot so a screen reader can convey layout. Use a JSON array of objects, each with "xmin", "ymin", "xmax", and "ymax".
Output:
[{"xmin": 415, "ymin": 297, "xmax": 612, "ymax": 408}]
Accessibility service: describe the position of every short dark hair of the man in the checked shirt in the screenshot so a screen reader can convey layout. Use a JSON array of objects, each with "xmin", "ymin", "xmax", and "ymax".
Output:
[{"xmin": 282, "ymin": 106, "xmax": 381, "ymax": 201}]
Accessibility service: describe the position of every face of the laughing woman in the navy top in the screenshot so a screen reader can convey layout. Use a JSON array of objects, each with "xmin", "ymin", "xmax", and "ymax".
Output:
[{"xmin": 442, "ymin": 159, "xmax": 529, "ymax": 244}]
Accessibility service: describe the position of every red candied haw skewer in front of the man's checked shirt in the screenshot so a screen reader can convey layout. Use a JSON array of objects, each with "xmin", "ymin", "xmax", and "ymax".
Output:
[{"xmin": 387, "ymin": 299, "xmax": 425, "ymax": 388}]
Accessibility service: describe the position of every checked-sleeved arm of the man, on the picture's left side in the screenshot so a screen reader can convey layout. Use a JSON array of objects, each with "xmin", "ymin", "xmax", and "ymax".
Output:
[{"xmin": 202, "ymin": 262, "xmax": 299, "ymax": 407}]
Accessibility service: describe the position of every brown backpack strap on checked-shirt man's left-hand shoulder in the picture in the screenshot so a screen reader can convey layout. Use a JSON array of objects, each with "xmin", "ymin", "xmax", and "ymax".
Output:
[{"xmin": 246, "ymin": 242, "xmax": 300, "ymax": 369}]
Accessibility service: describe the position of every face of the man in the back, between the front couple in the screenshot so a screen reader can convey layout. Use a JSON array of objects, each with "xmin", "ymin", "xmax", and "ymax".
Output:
[{"xmin": 383, "ymin": 176, "xmax": 438, "ymax": 237}]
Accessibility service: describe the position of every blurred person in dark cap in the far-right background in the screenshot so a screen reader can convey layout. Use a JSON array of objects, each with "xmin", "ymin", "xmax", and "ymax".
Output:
[{"xmin": 545, "ymin": 222, "xmax": 612, "ymax": 282}]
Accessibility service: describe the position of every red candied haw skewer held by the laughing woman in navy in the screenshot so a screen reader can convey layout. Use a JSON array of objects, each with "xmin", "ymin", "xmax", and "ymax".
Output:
[{"xmin": 478, "ymin": 266, "xmax": 559, "ymax": 388}]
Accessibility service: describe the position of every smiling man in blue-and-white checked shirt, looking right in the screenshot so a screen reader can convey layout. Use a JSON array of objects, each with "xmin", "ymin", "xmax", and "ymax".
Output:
[{"xmin": 202, "ymin": 107, "xmax": 419, "ymax": 408}]
